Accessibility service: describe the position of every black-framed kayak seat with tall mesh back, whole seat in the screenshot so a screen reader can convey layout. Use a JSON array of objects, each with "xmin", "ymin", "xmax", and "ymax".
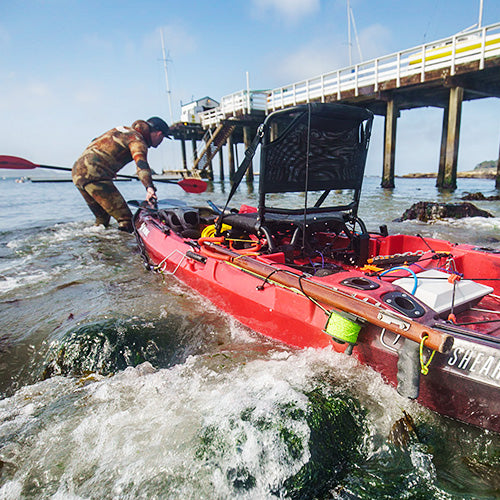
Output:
[{"xmin": 220, "ymin": 103, "xmax": 373, "ymax": 258}]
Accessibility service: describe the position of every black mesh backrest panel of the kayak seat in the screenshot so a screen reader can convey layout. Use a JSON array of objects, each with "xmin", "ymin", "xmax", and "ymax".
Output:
[{"xmin": 259, "ymin": 103, "xmax": 373, "ymax": 197}]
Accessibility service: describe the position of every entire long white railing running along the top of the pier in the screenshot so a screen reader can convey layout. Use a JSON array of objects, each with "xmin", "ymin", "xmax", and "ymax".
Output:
[{"xmin": 200, "ymin": 23, "xmax": 500, "ymax": 128}]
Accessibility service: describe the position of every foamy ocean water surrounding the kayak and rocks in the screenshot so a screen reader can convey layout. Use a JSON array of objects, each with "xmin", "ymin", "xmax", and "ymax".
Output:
[{"xmin": 0, "ymin": 177, "xmax": 500, "ymax": 500}]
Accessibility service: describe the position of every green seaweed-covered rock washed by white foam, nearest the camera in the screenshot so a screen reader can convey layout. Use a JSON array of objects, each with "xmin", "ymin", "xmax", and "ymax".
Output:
[{"xmin": 196, "ymin": 387, "xmax": 365, "ymax": 499}]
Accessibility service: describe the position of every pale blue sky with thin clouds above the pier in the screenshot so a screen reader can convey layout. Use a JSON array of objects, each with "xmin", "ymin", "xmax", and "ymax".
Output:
[{"xmin": 0, "ymin": 0, "xmax": 500, "ymax": 175}]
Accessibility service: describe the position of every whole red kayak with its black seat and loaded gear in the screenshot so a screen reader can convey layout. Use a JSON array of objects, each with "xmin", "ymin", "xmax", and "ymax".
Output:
[{"xmin": 134, "ymin": 104, "xmax": 500, "ymax": 432}]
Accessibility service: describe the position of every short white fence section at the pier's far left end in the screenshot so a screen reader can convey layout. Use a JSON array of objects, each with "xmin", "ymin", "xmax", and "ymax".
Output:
[{"xmin": 200, "ymin": 90, "xmax": 269, "ymax": 128}]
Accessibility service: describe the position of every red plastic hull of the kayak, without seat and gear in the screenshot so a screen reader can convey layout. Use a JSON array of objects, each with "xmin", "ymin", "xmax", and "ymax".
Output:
[{"xmin": 134, "ymin": 209, "xmax": 500, "ymax": 432}]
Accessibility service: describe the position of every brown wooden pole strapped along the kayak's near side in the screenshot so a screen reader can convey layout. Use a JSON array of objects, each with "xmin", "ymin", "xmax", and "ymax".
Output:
[{"xmin": 202, "ymin": 244, "xmax": 453, "ymax": 353}]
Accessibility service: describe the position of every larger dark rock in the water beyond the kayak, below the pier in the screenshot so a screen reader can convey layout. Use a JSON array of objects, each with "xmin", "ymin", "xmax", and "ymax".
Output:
[{"xmin": 394, "ymin": 201, "xmax": 493, "ymax": 222}]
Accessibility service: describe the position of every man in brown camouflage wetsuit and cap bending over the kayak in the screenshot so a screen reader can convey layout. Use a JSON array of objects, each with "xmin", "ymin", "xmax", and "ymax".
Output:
[{"xmin": 72, "ymin": 116, "xmax": 170, "ymax": 233}]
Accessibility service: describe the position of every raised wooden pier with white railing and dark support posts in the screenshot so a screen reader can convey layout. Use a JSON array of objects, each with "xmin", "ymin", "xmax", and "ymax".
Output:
[{"xmin": 173, "ymin": 23, "xmax": 500, "ymax": 190}]
